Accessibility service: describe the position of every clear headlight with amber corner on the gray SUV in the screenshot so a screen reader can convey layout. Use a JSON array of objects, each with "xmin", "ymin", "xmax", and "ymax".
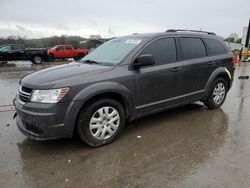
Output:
[{"xmin": 30, "ymin": 87, "xmax": 69, "ymax": 103}]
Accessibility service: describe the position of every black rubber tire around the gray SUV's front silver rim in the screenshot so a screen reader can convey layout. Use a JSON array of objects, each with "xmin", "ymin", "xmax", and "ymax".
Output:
[{"xmin": 76, "ymin": 98, "xmax": 126, "ymax": 147}]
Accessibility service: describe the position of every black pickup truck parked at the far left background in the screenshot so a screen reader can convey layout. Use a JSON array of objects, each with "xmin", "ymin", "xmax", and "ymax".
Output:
[{"xmin": 0, "ymin": 44, "xmax": 47, "ymax": 64}]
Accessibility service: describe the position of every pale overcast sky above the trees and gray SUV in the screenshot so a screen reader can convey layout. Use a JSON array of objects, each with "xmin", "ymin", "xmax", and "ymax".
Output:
[{"xmin": 0, "ymin": 0, "xmax": 250, "ymax": 38}]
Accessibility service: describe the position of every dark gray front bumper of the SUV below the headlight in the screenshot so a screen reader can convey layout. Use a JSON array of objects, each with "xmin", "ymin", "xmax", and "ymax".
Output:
[{"xmin": 14, "ymin": 98, "xmax": 77, "ymax": 140}]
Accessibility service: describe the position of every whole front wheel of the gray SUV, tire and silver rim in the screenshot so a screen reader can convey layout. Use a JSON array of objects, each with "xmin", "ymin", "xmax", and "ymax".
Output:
[{"xmin": 77, "ymin": 98, "xmax": 126, "ymax": 147}]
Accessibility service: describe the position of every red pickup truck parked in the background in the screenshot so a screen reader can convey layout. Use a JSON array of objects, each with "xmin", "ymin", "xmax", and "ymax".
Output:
[{"xmin": 48, "ymin": 45, "xmax": 88, "ymax": 60}]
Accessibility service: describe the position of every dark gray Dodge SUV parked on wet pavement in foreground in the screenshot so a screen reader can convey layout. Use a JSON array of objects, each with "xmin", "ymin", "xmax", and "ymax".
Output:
[{"xmin": 14, "ymin": 30, "xmax": 234, "ymax": 147}]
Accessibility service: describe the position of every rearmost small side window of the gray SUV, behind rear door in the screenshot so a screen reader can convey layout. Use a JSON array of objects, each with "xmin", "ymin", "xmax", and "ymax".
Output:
[{"xmin": 205, "ymin": 39, "xmax": 227, "ymax": 55}]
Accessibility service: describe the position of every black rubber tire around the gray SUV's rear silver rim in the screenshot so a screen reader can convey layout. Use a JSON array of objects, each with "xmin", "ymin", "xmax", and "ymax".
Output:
[{"xmin": 203, "ymin": 78, "xmax": 228, "ymax": 109}]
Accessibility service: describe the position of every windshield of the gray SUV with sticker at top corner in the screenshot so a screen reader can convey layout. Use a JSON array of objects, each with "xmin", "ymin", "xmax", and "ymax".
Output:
[{"xmin": 80, "ymin": 37, "xmax": 142, "ymax": 65}]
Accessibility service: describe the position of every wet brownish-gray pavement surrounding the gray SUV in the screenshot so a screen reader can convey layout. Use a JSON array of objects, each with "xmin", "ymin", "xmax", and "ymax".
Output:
[{"xmin": 0, "ymin": 62, "xmax": 250, "ymax": 188}]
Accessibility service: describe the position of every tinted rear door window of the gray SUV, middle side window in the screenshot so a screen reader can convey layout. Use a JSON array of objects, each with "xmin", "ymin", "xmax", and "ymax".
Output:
[{"xmin": 180, "ymin": 37, "xmax": 207, "ymax": 59}]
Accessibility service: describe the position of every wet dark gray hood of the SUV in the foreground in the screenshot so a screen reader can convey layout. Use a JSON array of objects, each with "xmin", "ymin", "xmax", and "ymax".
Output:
[{"xmin": 21, "ymin": 62, "xmax": 114, "ymax": 89}]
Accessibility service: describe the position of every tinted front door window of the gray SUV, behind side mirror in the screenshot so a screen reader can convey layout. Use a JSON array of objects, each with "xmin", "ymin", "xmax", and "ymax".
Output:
[{"xmin": 140, "ymin": 38, "xmax": 177, "ymax": 65}]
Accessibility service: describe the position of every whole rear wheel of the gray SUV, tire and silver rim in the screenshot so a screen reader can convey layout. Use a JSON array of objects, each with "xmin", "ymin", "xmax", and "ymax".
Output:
[{"xmin": 204, "ymin": 78, "xmax": 228, "ymax": 109}]
